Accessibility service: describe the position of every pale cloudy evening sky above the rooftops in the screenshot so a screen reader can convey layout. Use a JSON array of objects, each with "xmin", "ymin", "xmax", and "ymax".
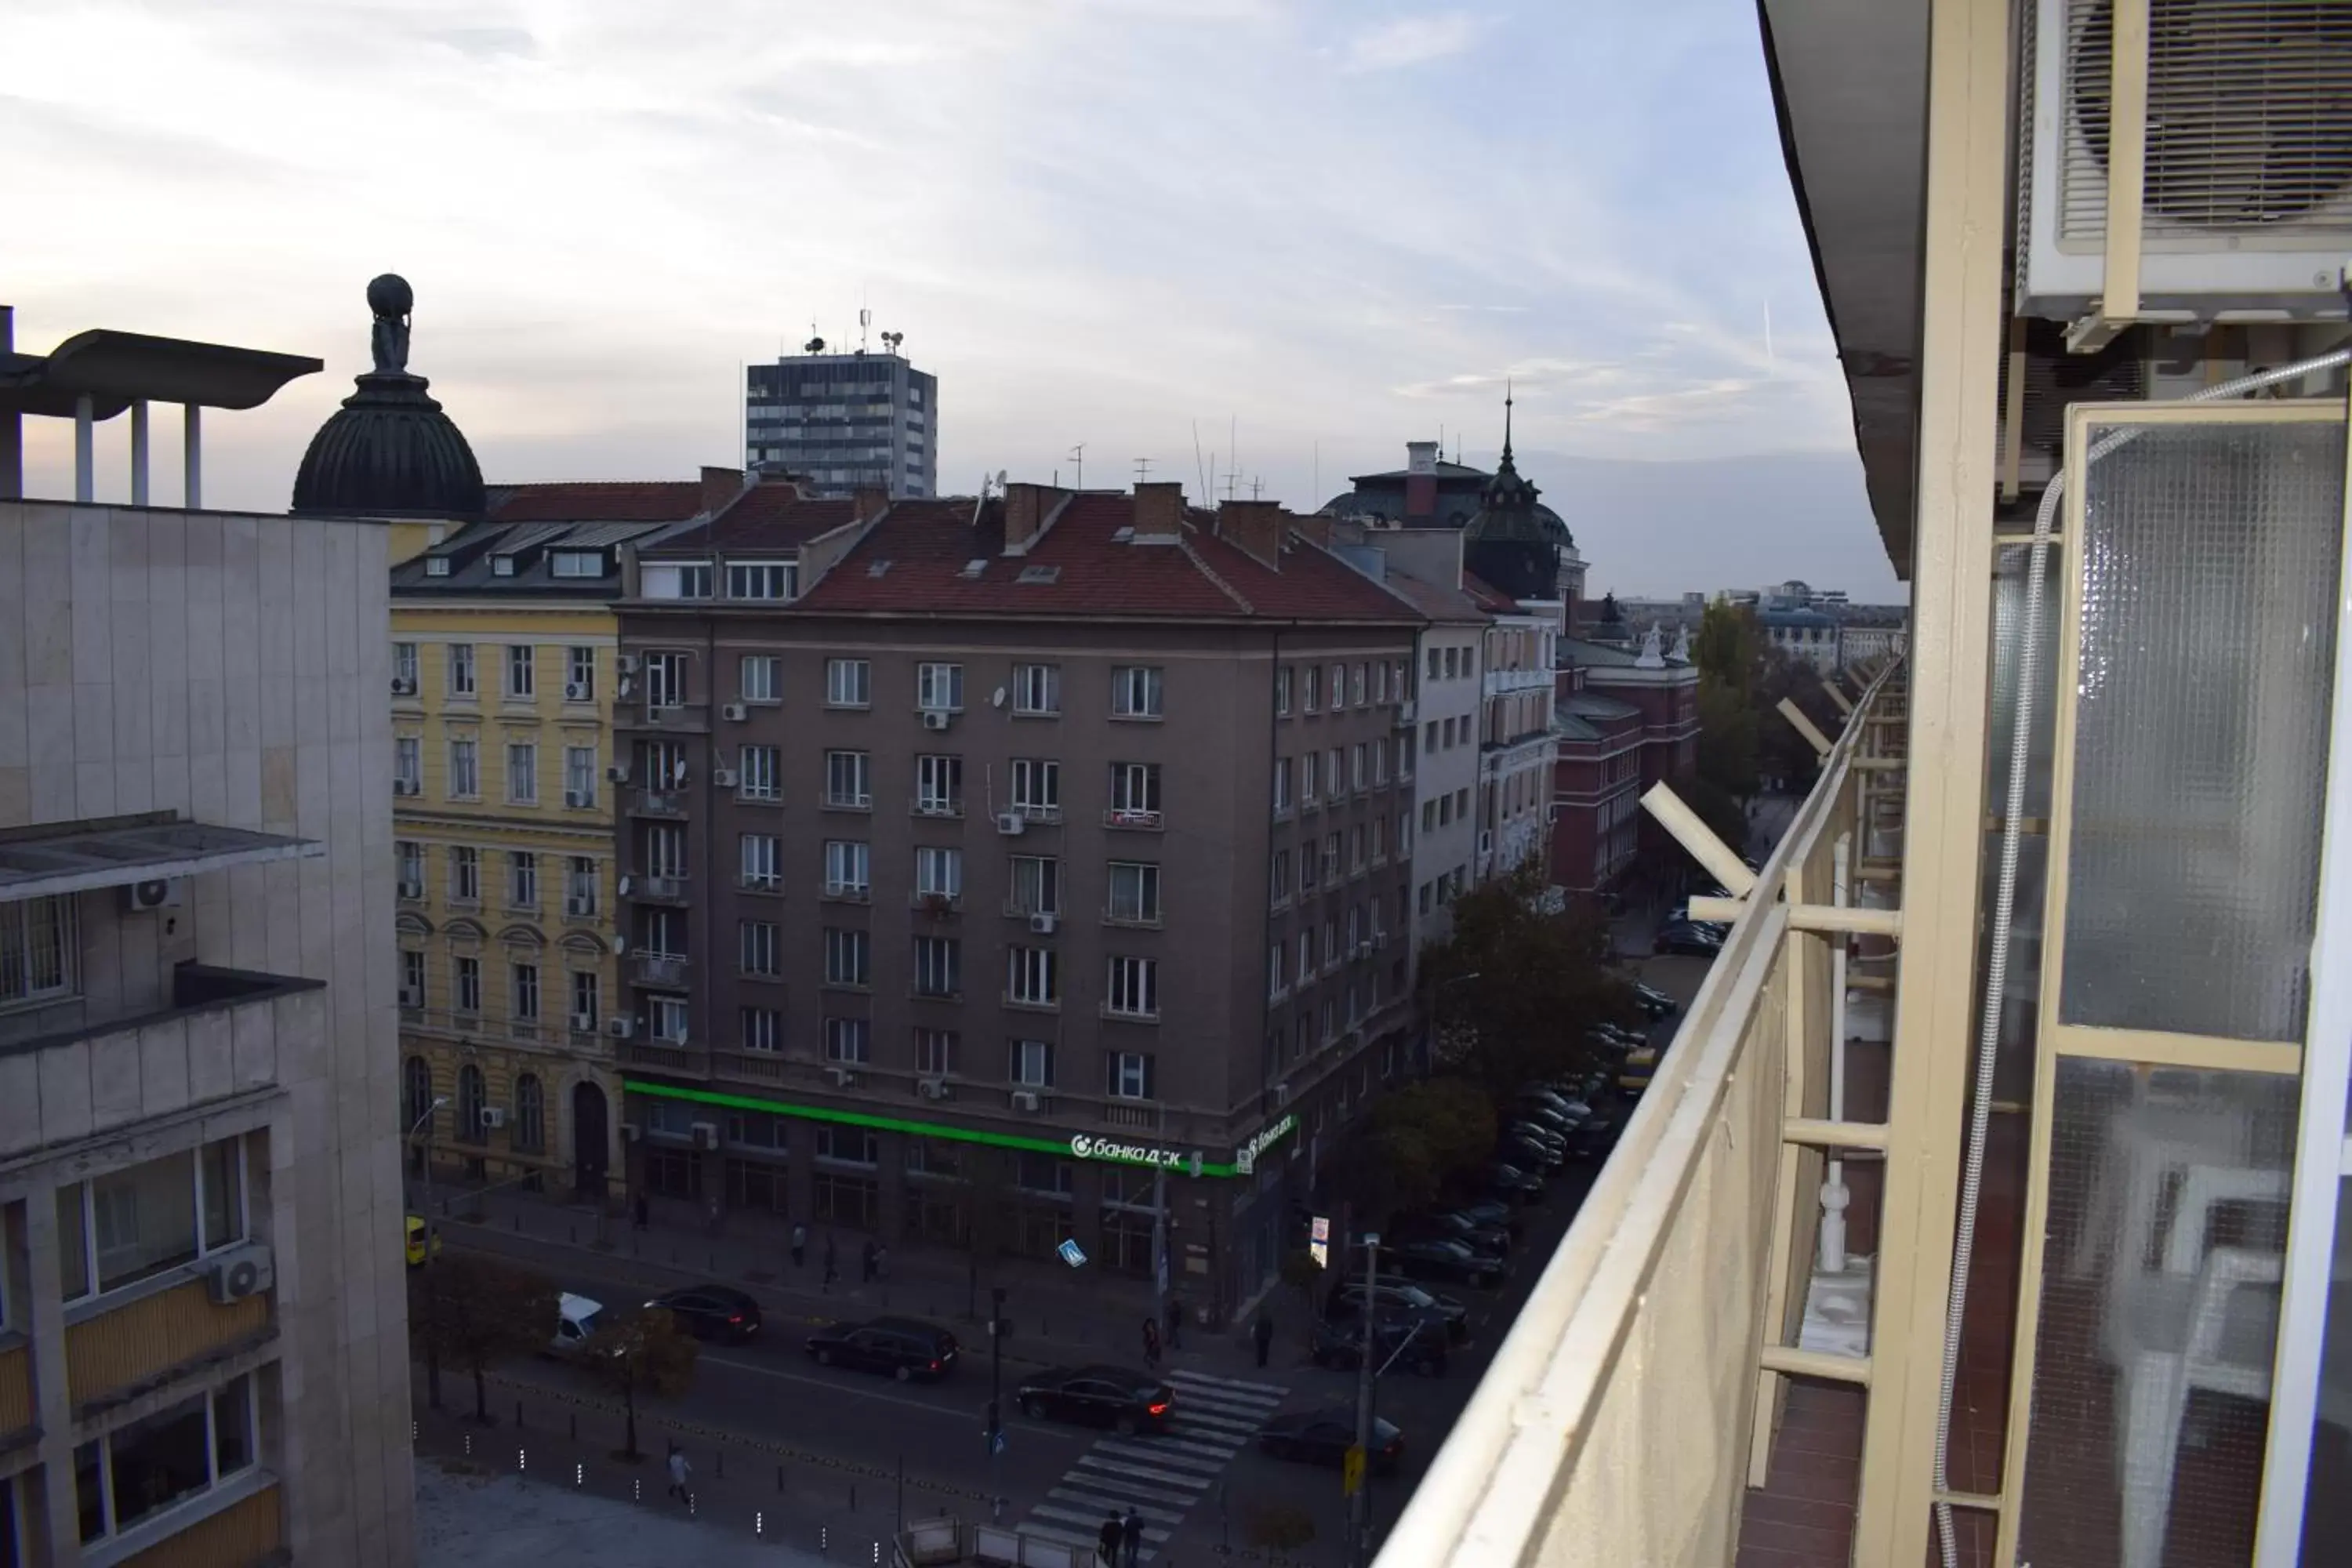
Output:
[{"xmin": 0, "ymin": 0, "xmax": 1900, "ymax": 600}]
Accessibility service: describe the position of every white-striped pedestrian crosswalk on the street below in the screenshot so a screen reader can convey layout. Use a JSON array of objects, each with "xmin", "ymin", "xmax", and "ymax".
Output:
[{"xmin": 1021, "ymin": 1370, "xmax": 1289, "ymax": 1563}]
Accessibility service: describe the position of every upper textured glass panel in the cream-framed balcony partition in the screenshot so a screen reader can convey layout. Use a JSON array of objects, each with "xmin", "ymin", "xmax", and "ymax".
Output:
[{"xmin": 2058, "ymin": 426, "xmax": 2345, "ymax": 1039}]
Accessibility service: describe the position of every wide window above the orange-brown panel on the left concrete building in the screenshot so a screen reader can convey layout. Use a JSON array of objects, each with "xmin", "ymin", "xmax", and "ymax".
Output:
[{"xmin": 56, "ymin": 1142, "xmax": 243, "ymax": 1302}]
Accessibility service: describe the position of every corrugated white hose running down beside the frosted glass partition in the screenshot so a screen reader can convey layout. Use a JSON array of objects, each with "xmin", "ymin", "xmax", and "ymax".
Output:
[{"xmin": 1936, "ymin": 348, "xmax": 2352, "ymax": 1568}]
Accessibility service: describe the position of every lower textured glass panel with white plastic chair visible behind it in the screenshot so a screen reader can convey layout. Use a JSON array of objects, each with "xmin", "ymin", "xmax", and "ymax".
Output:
[{"xmin": 2018, "ymin": 1058, "xmax": 2296, "ymax": 1568}]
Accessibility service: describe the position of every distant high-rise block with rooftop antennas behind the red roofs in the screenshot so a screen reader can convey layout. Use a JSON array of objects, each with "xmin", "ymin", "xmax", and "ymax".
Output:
[{"xmin": 743, "ymin": 339, "xmax": 938, "ymax": 501}]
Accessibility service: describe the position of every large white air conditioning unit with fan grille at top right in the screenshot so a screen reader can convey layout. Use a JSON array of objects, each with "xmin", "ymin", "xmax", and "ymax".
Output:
[{"xmin": 2018, "ymin": 0, "xmax": 2352, "ymax": 328}]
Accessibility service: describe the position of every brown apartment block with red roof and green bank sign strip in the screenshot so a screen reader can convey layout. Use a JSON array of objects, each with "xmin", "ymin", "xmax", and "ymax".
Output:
[{"xmin": 614, "ymin": 485, "xmax": 1423, "ymax": 1309}]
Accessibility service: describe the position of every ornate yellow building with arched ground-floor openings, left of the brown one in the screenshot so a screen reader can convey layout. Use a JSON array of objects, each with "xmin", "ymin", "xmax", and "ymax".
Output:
[{"xmin": 390, "ymin": 470, "xmax": 720, "ymax": 1199}]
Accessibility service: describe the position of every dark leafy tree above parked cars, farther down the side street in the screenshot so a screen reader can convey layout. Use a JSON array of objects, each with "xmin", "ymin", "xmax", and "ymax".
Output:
[{"xmin": 1421, "ymin": 862, "xmax": 1630, "ymax": 1102}]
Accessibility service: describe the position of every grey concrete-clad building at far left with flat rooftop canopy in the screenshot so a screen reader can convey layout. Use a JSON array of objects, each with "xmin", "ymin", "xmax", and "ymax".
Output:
[{"xmin": 0, "ymin": 310, "xmax": 414, "ymax": 1568}]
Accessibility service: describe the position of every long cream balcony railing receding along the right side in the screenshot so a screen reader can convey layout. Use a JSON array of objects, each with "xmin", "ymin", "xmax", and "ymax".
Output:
[{"xmin": 1378, "ymin": 658, "xmax": 1900, "ymax": 1568}]
